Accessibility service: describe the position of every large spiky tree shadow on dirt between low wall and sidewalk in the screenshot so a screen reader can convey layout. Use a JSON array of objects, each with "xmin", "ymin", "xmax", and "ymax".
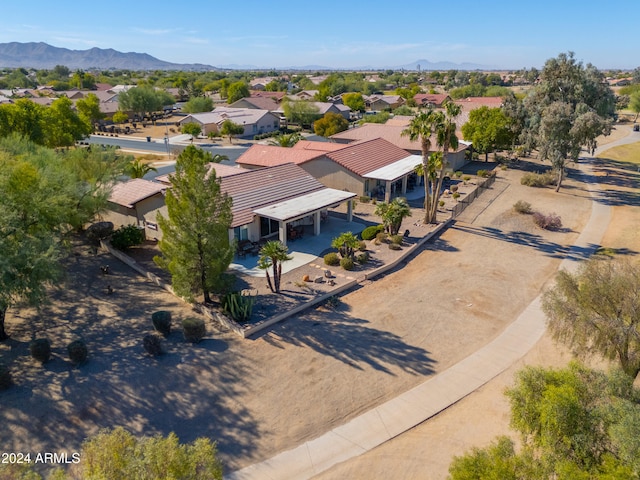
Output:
[{"xmin": 263, "ymin": 308, "xmax": 435, "ymax": 376}]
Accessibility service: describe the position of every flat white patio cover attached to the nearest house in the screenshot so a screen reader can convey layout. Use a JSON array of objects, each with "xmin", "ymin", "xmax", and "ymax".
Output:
[{"xmin": 253, "ymin": 188, "xmax": 356, "ymax": 221}]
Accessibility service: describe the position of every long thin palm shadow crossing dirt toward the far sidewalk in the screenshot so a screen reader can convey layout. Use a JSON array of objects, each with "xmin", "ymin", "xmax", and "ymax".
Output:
[{"xmin": 451, "ymin": 224, "xmax": 600, "ymax": 260}]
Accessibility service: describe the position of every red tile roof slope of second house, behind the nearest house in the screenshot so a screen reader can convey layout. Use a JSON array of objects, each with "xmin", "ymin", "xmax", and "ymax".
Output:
[{"xmin": 326, "ymin": 138, "xmax": 409, "ymax": 176}]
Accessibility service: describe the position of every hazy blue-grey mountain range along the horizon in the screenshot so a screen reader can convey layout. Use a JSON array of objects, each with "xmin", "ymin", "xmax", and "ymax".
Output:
[{"xmin": 0, "ymin": 42, "xmax": 496, "ymax": 71}]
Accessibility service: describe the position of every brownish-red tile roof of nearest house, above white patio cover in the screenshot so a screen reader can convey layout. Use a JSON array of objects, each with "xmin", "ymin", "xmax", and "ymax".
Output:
[{"xmin": 220, "ymin": 162, "xmax": 326, "ymax": 227}]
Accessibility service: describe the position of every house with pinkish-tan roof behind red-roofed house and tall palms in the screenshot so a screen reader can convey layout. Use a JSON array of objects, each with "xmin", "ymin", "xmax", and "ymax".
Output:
[{"xmin": 329, "ymin": 123, "xmax": 471, "ymax": 171}]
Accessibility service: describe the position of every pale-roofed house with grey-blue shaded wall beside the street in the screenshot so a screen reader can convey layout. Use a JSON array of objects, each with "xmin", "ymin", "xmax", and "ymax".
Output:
[{"xmin": 179, "ymin": 107, "xmax": 280, "ymax": 138}]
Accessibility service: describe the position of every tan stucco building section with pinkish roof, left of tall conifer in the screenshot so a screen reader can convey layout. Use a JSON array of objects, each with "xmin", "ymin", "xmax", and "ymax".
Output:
[{"xmin": 103, "ymin": 178, "xmax": 167, "ymax": 239}]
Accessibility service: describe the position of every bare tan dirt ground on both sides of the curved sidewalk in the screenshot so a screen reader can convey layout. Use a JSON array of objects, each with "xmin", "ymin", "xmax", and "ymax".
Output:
[{"xmin": 0, "ymin": 125, "xmax": 640, "ymax": 479}]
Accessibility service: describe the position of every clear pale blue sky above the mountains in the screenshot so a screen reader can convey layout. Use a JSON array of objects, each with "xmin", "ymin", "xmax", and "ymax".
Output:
[{"xmin": 0, "ymin": 0, "xmax": 640, "ymax": 69}]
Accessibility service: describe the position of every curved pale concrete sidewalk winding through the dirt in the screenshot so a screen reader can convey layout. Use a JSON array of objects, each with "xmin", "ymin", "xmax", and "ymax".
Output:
[{"xmin": 225, "ymin": 149, "xmax": 611, "ymax": 480}]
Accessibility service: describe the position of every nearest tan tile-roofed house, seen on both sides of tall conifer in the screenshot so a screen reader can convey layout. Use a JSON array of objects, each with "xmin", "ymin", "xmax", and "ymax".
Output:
[{"xmin": 105, "ymin": 163, "xmax": 356, "ymax": 248}]
